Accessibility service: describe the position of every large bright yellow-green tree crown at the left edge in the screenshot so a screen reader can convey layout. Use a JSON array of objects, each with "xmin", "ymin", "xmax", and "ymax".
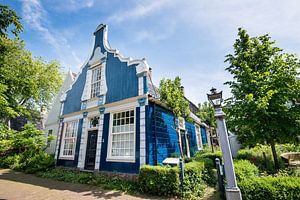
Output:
[{"xmin": 0, "ymin": 36, "xmax": 62, "ymax": 120}]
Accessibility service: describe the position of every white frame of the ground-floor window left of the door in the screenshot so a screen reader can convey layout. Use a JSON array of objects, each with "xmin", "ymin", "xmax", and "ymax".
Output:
[{"xmin": 59, "ymin": 120, "xmax": 79, "ymax": 160}]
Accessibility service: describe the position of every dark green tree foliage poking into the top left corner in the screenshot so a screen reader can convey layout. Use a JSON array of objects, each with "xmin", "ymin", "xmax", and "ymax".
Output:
[{"xmin": 0, "ymin": 4, "xmax": 23, "ymax": 37}]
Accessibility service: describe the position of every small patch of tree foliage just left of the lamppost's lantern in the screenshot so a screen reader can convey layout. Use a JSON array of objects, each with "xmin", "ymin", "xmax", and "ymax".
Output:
[{"xmin": 197, "ymin": 101, "xmax": 217, "ymax": 127}]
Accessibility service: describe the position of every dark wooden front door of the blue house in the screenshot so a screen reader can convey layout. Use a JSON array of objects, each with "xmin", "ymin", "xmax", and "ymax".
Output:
[{"xmin": 84, "ymin": 130, "xmax": 98, "ymax": 170}]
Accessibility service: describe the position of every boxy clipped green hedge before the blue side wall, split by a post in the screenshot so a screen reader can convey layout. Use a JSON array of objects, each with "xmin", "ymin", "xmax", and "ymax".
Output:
[{"xmin": 139, "ymin": 161, "xmax": 205, "ymax": 198}]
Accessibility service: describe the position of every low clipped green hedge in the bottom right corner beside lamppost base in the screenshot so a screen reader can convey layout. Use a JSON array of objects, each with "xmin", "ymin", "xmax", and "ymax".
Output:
[{"xmin": 238, "ymin": 176, "xmax": 300, "ymax": 200}]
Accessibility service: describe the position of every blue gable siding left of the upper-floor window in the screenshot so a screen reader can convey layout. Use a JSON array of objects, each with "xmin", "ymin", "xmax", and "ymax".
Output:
[{"xmin": 63, "ymin": 64, "xmax": 88, "ymax": 115}]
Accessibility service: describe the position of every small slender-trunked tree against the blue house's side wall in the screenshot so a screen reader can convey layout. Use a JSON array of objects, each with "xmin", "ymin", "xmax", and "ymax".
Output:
[{"xmin": 158, "ymin": 76, "xmax": 190, "ymax": 157}]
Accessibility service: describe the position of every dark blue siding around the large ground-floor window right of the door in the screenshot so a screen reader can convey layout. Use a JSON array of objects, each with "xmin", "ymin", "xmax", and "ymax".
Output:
[{"xmin": 100, "ymin": 108, "xmax": 140, "ymax": 174}]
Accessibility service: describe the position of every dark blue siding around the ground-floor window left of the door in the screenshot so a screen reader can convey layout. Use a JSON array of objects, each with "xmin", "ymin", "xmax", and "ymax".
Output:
[{"xmin": 56, "ymin": 119, "xmax": 83, "ymax": 167}]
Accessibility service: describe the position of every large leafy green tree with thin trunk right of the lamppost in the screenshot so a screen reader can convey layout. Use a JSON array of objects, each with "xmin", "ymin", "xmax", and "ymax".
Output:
[{"xmin": 225, "ymin": 28, "xmax": 300, "ymax": 169}]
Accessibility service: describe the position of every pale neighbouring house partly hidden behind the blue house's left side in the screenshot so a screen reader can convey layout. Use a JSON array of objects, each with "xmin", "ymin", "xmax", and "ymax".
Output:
[{"xmin": 44, "ymin": 70, "xmax": 76, "ymax": 154}]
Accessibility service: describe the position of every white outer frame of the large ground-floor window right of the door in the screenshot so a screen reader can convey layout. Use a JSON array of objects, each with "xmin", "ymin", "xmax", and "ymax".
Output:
[{"xmin": 106, "ymin": 108, "xmax": 136, "ymax": 163}]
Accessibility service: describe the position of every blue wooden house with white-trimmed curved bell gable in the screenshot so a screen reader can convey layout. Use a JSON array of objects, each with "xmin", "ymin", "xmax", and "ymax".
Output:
[{"xmin": 55, "ymin": 24, "xmax": 208, "ymax": 173}]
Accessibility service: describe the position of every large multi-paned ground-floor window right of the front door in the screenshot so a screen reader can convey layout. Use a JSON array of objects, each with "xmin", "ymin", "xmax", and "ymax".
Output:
[{"xmin": 108, "ymin": 110, "xmax": 135, "ymax": 160}]
